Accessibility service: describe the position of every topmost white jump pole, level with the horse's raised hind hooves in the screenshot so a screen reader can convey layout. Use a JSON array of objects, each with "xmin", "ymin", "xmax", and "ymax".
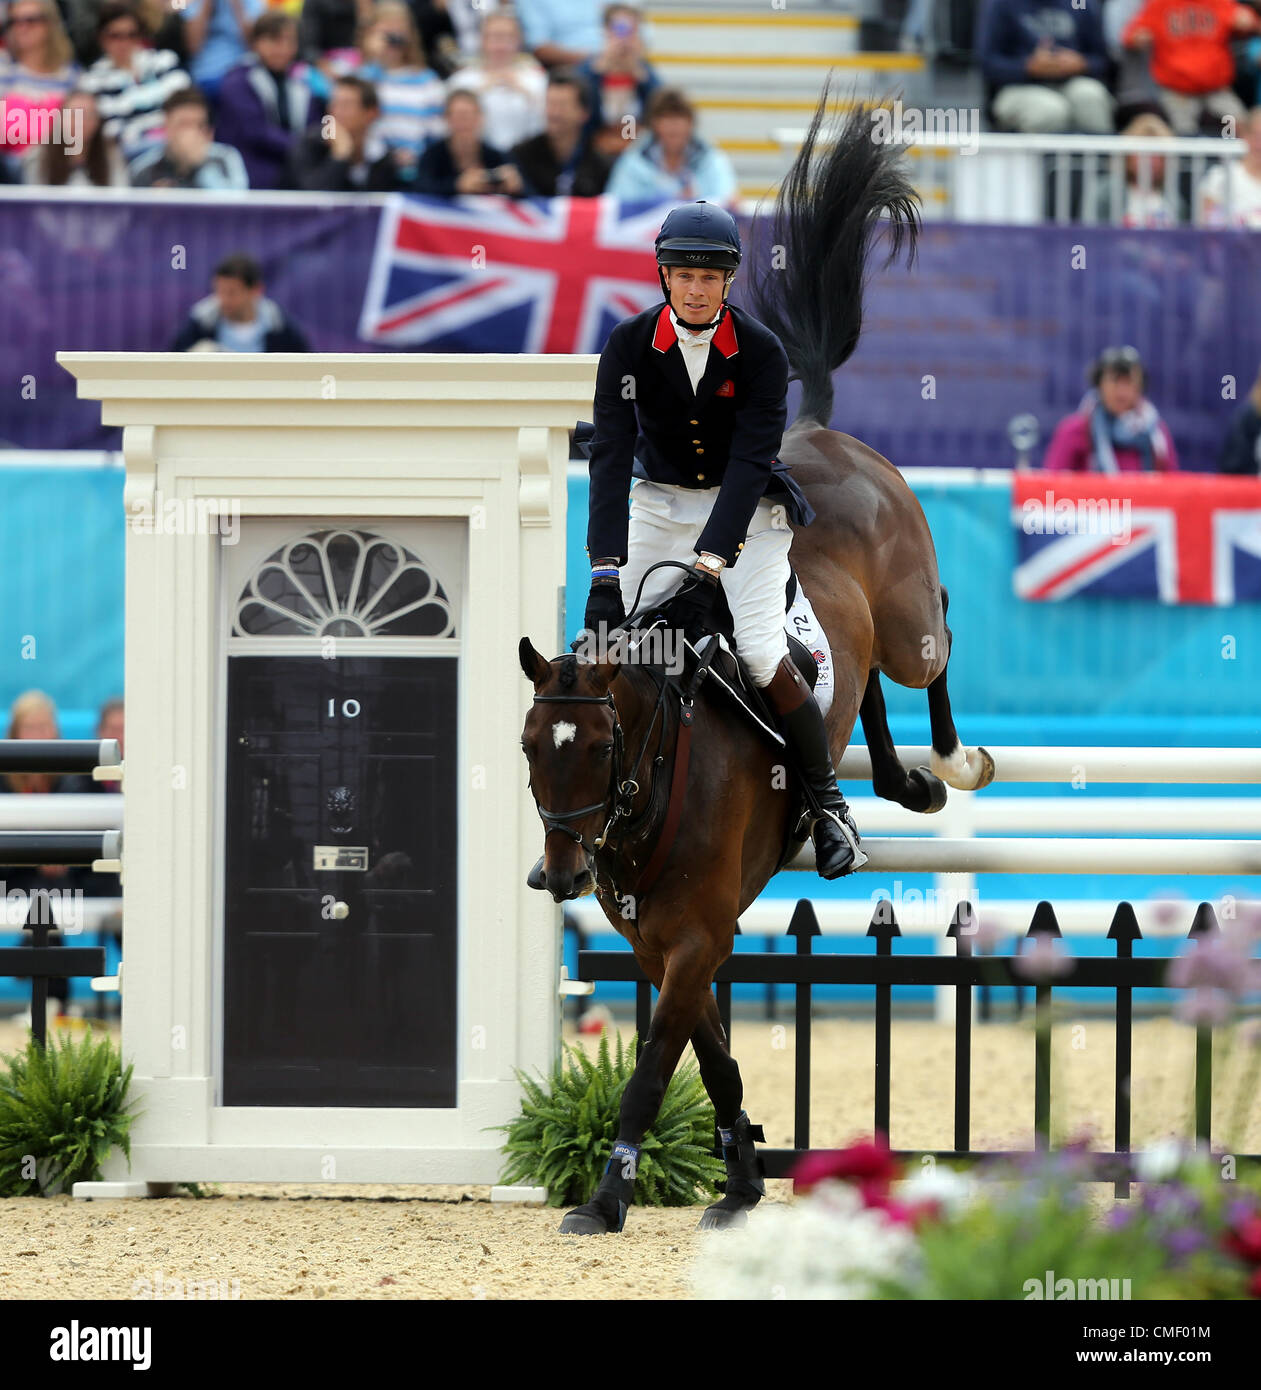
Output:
[{"xmin": 837, "ymin": 745, "xmax": 1261, "ymax": 785}]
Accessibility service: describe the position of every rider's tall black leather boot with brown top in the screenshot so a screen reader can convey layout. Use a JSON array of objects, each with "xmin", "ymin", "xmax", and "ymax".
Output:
[{"xmin": 765, "ymin": 656, "xmax": 868, "ymax": 878}]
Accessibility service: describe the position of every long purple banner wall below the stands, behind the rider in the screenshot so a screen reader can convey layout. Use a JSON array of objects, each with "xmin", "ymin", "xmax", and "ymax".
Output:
[{"xmin": 0, "ymin": 195, "xmax": 1261, "ymax": 470}]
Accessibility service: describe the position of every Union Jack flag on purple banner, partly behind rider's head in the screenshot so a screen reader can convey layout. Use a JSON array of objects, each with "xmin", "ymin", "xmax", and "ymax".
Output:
[{"xmin": 359, "ymin": 195, "xmax": 674, "ymax": 353}]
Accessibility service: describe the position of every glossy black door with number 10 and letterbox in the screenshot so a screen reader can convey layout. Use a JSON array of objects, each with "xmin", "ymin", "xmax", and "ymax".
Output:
[{"xmin": 224, "ymin": 656, "xmax": 459, "ymax": 1106}]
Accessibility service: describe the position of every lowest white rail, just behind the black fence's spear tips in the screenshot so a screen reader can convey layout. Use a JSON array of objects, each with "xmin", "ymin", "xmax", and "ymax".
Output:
[{"xmin": 566, "ymin": 888, "xmax": 1261, "ymax": 940}]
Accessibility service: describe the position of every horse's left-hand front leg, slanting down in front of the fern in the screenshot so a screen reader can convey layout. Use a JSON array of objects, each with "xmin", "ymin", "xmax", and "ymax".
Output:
[{"xmin": 560, "ymin": 942, "xmax": 716, "ymax": 1236}]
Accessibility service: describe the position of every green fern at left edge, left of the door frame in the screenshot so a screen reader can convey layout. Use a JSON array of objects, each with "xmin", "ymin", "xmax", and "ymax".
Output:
[{"xmin": 0, "ymin": 1034, "xmax": 133, "ymax": 1197}]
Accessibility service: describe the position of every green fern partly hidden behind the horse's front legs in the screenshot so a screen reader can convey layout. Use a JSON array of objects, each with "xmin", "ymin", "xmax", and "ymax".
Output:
[{"xmin": 495, "ymin": 1033, "xmax": 726, "ymax": 1207}]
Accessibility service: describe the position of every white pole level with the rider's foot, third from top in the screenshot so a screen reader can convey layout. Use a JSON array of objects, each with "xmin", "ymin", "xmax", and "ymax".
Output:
[{"xmin": 791, "ymin": 838, "xmax": 1261, "ymax": 874}]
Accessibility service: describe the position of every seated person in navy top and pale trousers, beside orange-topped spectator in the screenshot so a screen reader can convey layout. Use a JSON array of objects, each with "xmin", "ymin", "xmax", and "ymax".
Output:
[{"xmin": 976, "ymin": 0, "xmax": 1112, "ymax": 135}]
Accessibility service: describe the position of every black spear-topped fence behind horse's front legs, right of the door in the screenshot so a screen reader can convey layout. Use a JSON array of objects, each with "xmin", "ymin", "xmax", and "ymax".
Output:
[{"xmin": 577, "ymin": 898, "xmax": 1261, "ymax": 1197}]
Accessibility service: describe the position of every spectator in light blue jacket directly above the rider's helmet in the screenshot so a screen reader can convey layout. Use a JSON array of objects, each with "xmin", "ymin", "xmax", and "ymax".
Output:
[{"xmin": 605, "ymin": 88, "xmax": 740, "ymax": 206}]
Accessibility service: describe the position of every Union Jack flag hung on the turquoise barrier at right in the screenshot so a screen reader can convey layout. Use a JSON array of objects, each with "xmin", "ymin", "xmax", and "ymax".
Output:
[{"xmin": 1012, "ymin": 473, "xmax": 1261, "ymax": 605}]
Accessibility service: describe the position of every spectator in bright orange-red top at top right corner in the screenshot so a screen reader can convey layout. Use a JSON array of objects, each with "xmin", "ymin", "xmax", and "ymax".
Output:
[{"xmin": 1122, "ymin": 0, "xmax": 1261, "ymax": 135}]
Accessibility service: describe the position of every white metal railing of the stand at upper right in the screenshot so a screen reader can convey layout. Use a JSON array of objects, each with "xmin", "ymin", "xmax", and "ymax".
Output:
[{"xmin": 773, "ymin": 131, "xmax": 1247, "ymax": 227}]
